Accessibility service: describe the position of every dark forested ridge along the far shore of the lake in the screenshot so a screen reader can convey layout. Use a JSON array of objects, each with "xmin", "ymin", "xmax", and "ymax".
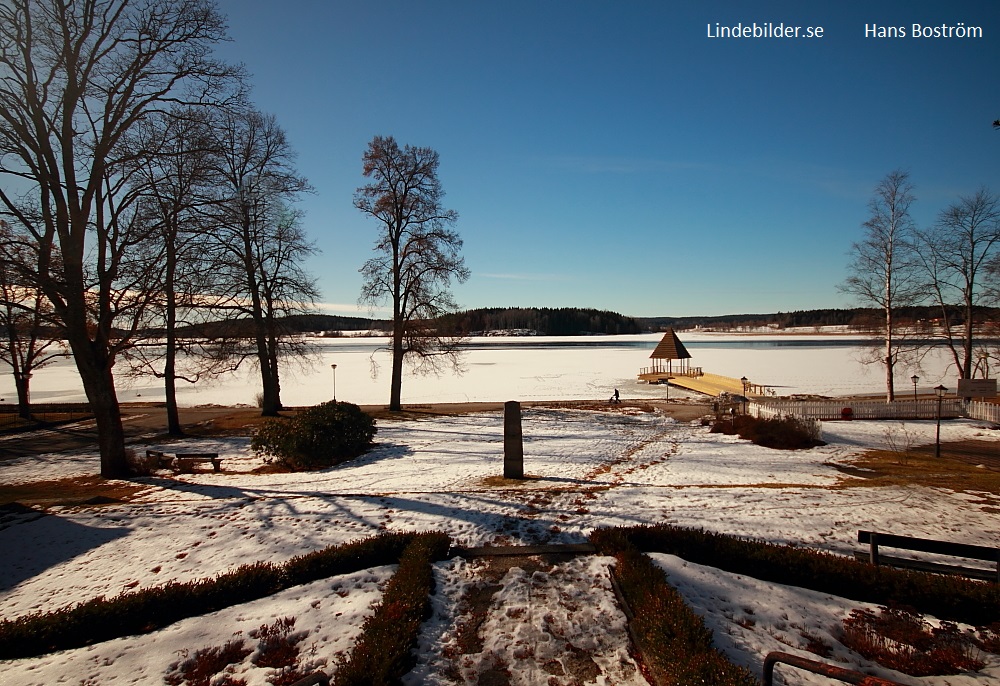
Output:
[{"xmin": 160, "ymin": 307, "xmax": 1000, "ymax": 336}]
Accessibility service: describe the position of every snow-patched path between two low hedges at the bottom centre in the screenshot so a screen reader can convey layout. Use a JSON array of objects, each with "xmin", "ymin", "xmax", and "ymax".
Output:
[{"xmin": 416, "ymin": 544, "xmax": 646, "ymax": 686}]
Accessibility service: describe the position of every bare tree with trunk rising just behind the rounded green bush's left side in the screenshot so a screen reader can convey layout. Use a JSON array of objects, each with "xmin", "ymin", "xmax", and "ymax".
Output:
[{"xmin": 212, "ymin": 109, "xmax": 318, "ymax": 415}]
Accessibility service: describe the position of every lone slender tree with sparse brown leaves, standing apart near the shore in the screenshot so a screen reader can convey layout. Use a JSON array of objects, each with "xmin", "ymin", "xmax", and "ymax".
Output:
[{"xmin": 354, "ymin": 136, "xmax": 469, "ymax": 411}]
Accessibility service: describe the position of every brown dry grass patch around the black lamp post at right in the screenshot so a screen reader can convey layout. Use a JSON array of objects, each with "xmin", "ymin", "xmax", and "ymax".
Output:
[{"xmin": 836, "ymin": 443, "xmax": 1000, "ymax": 496}]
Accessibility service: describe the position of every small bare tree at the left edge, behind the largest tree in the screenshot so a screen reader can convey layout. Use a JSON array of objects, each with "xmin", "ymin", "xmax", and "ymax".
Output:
[{"xmin": 0, "ymin": 220, "xmax": 62, "ymax": 419}]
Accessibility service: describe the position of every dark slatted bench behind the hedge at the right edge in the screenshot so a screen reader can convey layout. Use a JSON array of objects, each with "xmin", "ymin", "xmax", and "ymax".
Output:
[{"xmin": 854, "ymin": 531, "xmax": 1000, "ymax": 583}]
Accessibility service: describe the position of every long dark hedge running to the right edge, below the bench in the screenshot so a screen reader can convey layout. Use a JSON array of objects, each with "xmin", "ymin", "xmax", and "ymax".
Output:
[{"xmin": 590, "ymin": 524, "xmax": 1000, "ymax": 626}]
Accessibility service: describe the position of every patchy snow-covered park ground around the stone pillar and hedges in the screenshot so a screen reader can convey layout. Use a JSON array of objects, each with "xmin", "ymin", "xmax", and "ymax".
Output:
[{"xmin": 0, "ymin": 407, "xmax": 1000, "ymax": 686}]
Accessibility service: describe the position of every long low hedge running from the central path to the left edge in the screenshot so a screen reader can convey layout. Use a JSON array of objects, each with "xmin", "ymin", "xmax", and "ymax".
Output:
[{"xmin": 0, "ymin": 533, "xmax": 418, "ymax": 660}]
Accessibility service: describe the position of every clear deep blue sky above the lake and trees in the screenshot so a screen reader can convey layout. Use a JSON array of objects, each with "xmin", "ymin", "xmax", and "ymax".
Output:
[{"xmin": 211, "ymin": 0, "xmax": 1000, "ymax": 316}]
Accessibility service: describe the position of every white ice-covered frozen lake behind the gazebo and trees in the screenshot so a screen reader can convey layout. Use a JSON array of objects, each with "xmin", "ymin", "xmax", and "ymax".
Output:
[{"xmin": 0, "ymin": 332, "xmax": 955, "ymax": 406}]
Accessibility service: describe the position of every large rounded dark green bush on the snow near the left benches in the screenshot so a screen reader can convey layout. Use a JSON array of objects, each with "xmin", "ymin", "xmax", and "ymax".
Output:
[{"xmin": 250, "ymin": 401, "xmax": 377, "ymax": 471}]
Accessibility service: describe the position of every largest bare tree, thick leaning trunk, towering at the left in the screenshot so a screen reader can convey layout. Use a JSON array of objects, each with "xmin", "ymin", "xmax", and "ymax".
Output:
[{"xmin": 0, "ymin": 0, "xmax": 233, "ymax": 477}]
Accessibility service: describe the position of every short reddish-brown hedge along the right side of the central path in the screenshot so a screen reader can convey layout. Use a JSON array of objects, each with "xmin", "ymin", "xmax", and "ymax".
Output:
[{"xmin": 614, "ymin": 545, "xmax": 759, "ymax": 686}]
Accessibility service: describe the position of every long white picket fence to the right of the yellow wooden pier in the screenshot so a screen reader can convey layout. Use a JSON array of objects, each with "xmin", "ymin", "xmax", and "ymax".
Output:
[{"xmin": 747, "ymin": 398, "xmax": 968, "ymax": 422}]
